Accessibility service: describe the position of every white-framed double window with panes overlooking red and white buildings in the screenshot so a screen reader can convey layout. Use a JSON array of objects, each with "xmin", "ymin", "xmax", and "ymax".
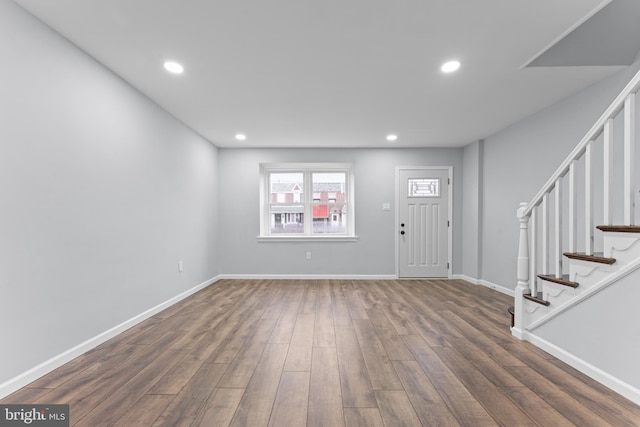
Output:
[{"xmin": 260, "ymin": 163, "xmax": 355, "ymax": 240}]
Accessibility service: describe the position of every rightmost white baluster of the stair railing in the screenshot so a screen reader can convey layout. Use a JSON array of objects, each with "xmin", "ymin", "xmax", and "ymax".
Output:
[{"xmin": 623, "ymin": 93, "xmax": 636, "ymax": 225}]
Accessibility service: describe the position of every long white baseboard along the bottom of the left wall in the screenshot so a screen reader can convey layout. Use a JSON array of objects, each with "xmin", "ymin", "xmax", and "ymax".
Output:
[{"xmin": 0, "ymin": 276, "xmax": 220, "ymax": 399}]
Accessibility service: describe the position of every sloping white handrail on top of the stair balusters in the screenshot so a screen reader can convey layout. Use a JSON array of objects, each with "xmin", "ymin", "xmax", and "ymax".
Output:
[{"xmin": 519, "ymin": 70, "xmax": 640, "ymax": 217}]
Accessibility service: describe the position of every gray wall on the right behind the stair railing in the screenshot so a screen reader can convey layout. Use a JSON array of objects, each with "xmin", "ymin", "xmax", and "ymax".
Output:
[{"xmin": 478, "ymin": 61, "xmax": 640, "ymax": 289}]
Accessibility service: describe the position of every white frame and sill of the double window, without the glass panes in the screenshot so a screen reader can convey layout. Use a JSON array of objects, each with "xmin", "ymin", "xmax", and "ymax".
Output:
[{"xmin": 258, "ymin": 163, "xmax": 358, "ymax": 242}]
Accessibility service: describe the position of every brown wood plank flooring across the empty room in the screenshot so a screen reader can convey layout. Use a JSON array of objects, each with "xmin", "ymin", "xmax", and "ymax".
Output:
[{"xmin": 0, "ymin": 280, "xmax": 640, "ymax": 427}]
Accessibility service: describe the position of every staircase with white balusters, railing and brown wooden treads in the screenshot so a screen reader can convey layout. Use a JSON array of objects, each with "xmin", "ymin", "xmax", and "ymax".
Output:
[{"xmin": 509, "ymin": 67, "xmax": 640, "ymax": 339}]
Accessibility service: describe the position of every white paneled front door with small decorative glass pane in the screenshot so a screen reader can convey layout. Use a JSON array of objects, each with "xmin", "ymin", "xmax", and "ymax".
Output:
[{"xmin": 397, "ymin": 168, "xmax": 450, "ymax": 277}]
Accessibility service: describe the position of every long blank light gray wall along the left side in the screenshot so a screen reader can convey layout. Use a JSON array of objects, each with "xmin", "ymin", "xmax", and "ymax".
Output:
[{"xmin": 0, "ymin": 1, "xmax": 218, "ymax": 384}]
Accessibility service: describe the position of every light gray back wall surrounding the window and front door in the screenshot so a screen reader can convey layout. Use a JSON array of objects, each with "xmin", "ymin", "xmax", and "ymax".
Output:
[{"xmin": 219, "ymin": 148, "xmax": 463, "ymax": 276}]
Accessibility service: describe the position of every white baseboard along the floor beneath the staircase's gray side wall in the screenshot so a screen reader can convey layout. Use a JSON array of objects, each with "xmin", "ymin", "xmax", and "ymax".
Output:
[{"xmin": 514, "ymin": 332, "xmax": 640, "ymax": 405}]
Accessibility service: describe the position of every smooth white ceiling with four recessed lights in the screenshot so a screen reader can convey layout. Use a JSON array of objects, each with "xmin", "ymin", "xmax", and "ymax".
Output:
[{"xmin": 16, "ymin": 0, "xmax": 640, "ymax": 147}]
